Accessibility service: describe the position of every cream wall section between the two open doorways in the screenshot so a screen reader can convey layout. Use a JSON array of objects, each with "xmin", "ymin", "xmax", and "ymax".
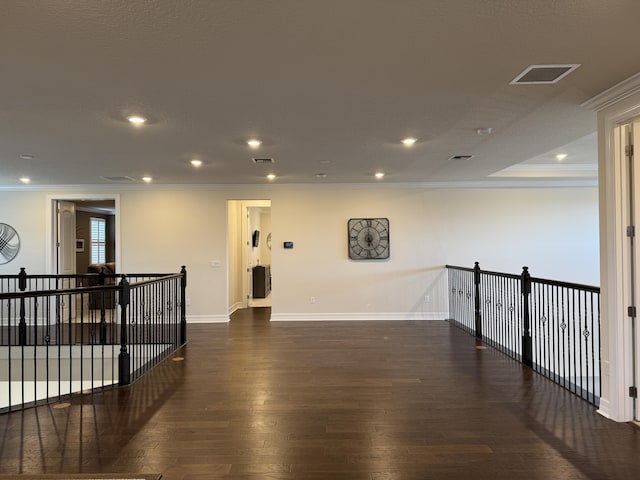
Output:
[{"xmin": 120, "ymin": 190, "xmax": 228, "ymax": 320}]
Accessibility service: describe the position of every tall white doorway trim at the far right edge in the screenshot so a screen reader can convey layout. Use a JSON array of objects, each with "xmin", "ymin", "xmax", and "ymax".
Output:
[{"xmin": 583, "ymin": 74, "xmax": 640, "ymax": 422}]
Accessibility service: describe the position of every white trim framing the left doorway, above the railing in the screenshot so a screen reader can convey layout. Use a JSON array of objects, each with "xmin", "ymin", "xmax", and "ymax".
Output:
[{"xmin": 45, "ymin": 193, "xmax": 122, "ymax": 275}]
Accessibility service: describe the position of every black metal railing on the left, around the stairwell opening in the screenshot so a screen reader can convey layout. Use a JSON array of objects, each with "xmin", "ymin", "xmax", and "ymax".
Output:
[{"xmin": 0, "ymin": 267, "xmax": 187, "ymax": 412}]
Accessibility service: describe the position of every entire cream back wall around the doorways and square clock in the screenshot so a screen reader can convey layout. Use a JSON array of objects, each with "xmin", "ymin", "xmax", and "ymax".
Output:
[{"xmin": 0, "ymin": 185, "xmax": 599, "ymax": 321}]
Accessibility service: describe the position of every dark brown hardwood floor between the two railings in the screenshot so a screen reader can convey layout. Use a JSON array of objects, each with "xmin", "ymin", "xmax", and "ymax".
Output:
[{"xmin": 0, "ymin": 308, "xmax": 640, "ymax": 480}]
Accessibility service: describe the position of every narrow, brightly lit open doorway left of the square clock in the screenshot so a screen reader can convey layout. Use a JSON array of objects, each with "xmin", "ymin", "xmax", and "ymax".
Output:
[{"xmin": 227, "ymin": 200, "xmax": 273, "ymax": 315}]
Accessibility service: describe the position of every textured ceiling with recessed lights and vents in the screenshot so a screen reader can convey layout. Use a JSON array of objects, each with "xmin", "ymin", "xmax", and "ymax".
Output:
[{"xmin": 0, "ymin": 0, "xmax": 640, "ymax": 187}]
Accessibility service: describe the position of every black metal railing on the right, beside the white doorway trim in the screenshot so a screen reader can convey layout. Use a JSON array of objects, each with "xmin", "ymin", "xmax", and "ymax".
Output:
[{"xmin": 447, "ymin": 262, "xmax": 601, "ymax": 405}]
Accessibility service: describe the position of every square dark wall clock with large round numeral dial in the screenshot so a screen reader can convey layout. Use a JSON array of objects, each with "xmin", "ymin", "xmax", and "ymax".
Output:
[{"xmin": 347, "ymin": 218, "xmax": 389, "ymax": 260}]
